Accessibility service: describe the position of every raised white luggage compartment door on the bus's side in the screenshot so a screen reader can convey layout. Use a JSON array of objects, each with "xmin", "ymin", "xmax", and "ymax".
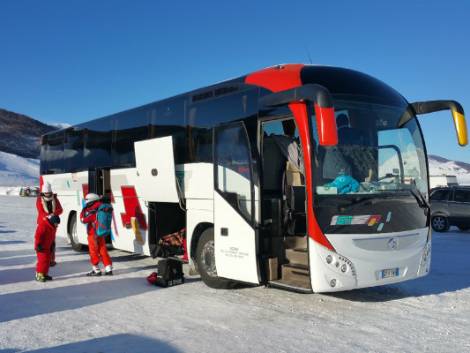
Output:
[{"xmin": 134, "ymin": 136, "xmax": 179, "ymax": 202}]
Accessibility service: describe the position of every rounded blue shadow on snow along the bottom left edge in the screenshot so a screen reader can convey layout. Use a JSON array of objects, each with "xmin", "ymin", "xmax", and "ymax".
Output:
[{"xmin": 0, "ymin": 334, "xmax": 180, "ymax": 353}]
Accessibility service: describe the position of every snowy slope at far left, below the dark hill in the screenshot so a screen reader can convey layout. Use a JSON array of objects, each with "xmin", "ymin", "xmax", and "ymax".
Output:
[{"xmin": 0, "ymin": 151, "xmax": 39, "ymax": 188}]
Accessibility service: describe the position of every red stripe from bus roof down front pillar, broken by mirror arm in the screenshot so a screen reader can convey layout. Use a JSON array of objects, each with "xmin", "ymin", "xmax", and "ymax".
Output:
[{"xmin": 245, "ymin": 64, "xmax": 334, "ymax": 251}]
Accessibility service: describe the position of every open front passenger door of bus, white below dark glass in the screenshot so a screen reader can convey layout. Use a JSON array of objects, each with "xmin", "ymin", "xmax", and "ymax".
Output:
[{"xmin": 214, "ymin": 122, "xmax": 259, "ymax": 284}]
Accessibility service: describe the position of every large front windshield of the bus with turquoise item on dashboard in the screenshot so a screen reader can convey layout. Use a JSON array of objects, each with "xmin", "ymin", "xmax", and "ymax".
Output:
[{"xmin": 312, "ymin": 98, "xmax": 428, "ymax": 197}]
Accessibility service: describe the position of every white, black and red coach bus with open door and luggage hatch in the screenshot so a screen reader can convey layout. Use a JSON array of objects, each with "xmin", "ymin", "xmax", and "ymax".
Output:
[{"xmin": 41, "ymin": 64, "xmax": 467, "ymax": 292}]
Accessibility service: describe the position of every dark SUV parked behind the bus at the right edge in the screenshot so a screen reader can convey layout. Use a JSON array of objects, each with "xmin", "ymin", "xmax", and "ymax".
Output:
[{"xmin": 430, "ymin": 186, "xmax": 470, "ymax": 232}]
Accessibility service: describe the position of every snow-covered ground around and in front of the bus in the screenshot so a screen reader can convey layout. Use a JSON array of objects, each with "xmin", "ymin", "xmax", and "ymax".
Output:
[{"xmin": 0, "ymin": 196, "xmax": 470, "ymax": 353}]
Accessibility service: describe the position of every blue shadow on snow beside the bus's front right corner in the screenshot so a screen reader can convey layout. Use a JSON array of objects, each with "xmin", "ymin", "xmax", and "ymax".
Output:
[{"xmin": 328, "ymin": 232, "xmax": 470, "ymax": 302}]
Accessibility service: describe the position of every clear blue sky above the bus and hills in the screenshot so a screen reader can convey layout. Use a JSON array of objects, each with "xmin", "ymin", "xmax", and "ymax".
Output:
[{"xmin": 0, "ymin": 0, "xmax": 470, "ymax": 162}]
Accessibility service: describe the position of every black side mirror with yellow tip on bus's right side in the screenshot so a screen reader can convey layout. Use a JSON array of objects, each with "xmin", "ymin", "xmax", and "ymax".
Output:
[{"xmin": 403, "ymin": 100, "xmax": 468, "ymax": 146}]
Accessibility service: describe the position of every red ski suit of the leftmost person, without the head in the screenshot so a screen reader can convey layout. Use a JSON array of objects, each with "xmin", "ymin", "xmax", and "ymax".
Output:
[{"xmin": 34, "ymin": 215, "xmax": 60, "ymax": 282}]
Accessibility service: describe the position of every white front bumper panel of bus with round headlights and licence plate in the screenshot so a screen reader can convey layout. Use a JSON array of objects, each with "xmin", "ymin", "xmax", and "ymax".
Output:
[{"xmin": 309, "ymin": 228, "xmax": 431, "ymax": 292}]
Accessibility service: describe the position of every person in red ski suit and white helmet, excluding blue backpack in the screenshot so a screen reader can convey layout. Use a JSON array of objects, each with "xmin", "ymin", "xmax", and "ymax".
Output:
[{"xmin": 80, "ymin": 194, "xmax": 113, "ymax": 276}]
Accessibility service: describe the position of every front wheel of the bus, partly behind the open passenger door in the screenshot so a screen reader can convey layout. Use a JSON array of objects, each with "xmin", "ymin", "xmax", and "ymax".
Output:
[{"xmin": 196, "ymin": 228, "xmax": 237, "ymax": 289}]
